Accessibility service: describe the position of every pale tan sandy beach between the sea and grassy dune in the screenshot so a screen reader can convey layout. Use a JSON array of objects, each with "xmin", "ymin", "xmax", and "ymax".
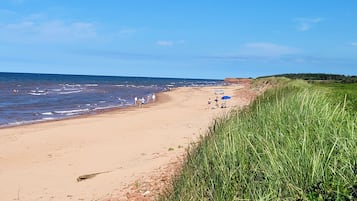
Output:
[{"xmin": 0, "ymin": 85, "xmax": 250, "ymax": 201}]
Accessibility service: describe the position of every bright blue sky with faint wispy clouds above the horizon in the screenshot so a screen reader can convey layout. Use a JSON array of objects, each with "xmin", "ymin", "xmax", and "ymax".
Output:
[{"xmin": 0, "ymin": 0, "xmax": 357, "ymax": 79}]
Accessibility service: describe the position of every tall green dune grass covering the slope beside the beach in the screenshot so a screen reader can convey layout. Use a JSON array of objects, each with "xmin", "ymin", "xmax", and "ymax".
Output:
[{"xmin": 160, "ymin": 81, "xmax": 357, "ymax": 201}]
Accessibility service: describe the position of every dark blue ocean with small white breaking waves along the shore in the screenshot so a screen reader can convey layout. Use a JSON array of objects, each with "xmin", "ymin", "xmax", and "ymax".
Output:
[{"xmin": 0, "ymin": 73, "xmax": 223, "ymax": 127}]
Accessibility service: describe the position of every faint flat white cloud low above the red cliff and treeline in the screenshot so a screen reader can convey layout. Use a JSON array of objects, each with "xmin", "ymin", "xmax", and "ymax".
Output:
[{"xmin": 240, "ymin": 42, "xmax": 300, "ymax": 57}]
